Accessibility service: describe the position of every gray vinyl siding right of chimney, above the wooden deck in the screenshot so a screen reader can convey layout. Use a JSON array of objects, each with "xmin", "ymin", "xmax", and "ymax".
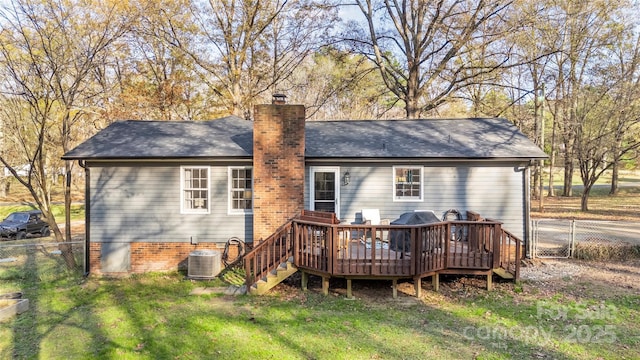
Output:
[{"xmin": 305, "ymin": 162, "xmax": 526, "ymax": 239}]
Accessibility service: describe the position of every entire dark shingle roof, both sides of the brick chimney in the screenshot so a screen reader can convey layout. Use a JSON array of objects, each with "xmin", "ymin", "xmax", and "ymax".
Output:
[{"xmin": 63, "ymin": 116, "xmax": 546, "ymax": 160}]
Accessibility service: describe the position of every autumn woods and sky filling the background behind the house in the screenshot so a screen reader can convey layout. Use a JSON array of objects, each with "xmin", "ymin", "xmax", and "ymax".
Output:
[{"xmin": 0, "ymin": 0, "xmax": 640, "ymax": 245}]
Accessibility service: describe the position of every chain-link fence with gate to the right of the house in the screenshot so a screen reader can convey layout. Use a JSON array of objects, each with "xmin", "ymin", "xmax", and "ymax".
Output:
[{"xmin": 529, "ymin": 219, "xmax": 640, "ymax": 260}]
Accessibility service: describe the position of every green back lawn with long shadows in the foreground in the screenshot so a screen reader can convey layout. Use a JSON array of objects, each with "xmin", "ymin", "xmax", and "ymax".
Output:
[{"xmin": 0, "ymin": 261, "xmax": 640, "ymax": 359}]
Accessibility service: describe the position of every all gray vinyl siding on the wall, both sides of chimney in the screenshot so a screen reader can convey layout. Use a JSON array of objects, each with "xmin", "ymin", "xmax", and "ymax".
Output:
[{"xmin": 89, "ymin": 162, "xmax": 526, "ymax": 243}]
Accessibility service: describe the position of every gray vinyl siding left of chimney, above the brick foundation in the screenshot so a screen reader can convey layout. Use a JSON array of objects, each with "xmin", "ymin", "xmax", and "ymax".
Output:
[{"xmin": 90, "ymin": 163, "xmax": 253, "ymax": 243}]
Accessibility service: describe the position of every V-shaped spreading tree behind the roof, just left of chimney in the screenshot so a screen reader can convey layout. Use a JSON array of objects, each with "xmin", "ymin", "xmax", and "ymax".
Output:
[{"xmin": 160, "ymin": 0, "xmax": 335, "ymax": 118}]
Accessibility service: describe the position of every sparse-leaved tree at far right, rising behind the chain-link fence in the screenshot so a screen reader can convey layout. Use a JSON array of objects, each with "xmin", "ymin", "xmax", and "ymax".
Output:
[{"xmin": 548, "ymin": 1, "xmax": 640, "ymax": 211}]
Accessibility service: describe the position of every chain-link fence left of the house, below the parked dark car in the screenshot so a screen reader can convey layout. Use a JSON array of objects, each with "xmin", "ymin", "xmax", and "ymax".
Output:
[{"xmin": 0, "ymin": 239, "xmax": 85, "ymax": 279}]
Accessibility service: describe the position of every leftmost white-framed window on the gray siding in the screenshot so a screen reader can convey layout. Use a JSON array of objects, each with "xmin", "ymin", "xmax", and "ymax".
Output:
[{"xmin": 180, "ymin": 166, "xmax": 210, "ymax": 214}]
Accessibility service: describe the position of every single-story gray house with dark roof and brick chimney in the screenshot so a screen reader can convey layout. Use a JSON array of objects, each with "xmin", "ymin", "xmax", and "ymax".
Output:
[{"xmin": 63, "ymin": 97, "xmax": 546, "ymax": 273}]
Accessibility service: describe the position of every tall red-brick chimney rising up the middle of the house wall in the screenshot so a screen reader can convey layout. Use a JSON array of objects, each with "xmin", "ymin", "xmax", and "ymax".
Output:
[{"xmin": 253, "ymin": 94, "xmax": 305, "ymax": 241}]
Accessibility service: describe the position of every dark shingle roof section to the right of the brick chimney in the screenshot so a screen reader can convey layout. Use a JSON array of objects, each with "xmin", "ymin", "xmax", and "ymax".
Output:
[{"xmin": 306, "ymin": 119, "xmax": 546, "ymax": 159}]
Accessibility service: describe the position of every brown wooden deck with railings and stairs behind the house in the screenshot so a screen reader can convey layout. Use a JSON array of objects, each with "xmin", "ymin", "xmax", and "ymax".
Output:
[{"xmin": 245, "ymin": 211, "xmax": 522, "ymax": 295}]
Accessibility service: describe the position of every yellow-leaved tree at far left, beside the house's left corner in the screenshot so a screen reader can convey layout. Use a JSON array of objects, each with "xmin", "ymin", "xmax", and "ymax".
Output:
[{"xmin": 0, "ymin": 0, "xmax": 131, "ymax": 267}]
